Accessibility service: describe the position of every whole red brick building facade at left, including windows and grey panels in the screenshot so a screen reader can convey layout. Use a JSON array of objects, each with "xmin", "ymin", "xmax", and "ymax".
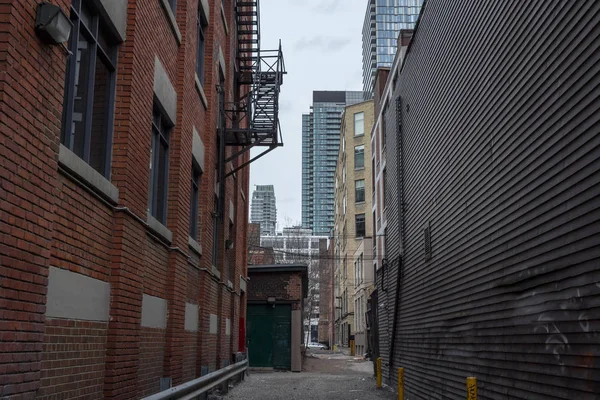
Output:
[{"xmin": 0, "ymin": 0, "xmax": 282, "ymax": 399}]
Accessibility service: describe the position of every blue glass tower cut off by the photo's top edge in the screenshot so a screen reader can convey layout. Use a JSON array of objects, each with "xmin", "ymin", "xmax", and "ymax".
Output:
[{"xmin": 363, "ymin": 0, "xmax": 423, "ymax": 99}]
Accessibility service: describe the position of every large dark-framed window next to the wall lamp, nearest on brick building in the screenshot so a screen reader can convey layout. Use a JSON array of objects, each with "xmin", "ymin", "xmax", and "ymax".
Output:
[{"xmin": 61, "ymin": 0, "xmax": 117, "ymax": 177}]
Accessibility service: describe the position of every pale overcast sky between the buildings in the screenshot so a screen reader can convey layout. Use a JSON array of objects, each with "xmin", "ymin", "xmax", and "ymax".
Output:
[{"xmin": 250, "ymin": 0, "xmax": 368, "ymax": 229}]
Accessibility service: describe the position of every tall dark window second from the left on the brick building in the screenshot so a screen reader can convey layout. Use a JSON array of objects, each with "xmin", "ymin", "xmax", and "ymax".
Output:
[{"xmin": 148, "ymin": 103, "xmax": 172, "ymax": 225}]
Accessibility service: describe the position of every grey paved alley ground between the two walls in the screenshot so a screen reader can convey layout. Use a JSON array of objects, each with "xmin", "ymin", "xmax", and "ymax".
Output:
[{"xmin": 223, "ymin": 352, "xmax": 396, "ymax": 400}]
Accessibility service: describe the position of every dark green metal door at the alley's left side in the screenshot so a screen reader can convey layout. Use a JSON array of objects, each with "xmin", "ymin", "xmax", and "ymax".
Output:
[{"xmin": 247, "ymin": 304, "xmax": 292, "ymax": 369}]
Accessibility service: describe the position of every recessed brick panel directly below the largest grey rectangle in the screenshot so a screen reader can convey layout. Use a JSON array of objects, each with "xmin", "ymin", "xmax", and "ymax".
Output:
[{"xmin": 37, "ymin": 319, "xmax": 108, "ymax": 399}]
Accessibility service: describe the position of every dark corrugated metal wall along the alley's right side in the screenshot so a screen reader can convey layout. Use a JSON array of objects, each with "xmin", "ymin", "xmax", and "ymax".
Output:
[{"xmin": 378, "ymin": 0, "xmax": 600, "ymax": 400}]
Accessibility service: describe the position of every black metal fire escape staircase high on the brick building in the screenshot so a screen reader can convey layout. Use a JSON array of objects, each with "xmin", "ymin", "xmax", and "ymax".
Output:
[{"xmin": 220, "ymin": 0, "xmax": 286, "ymax": 176}]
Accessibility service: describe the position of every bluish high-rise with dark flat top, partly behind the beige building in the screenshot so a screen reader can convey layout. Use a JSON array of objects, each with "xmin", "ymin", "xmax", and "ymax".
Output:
[{"xmin": 302, "ymin": 91, "xmax": 364, "ymax": 236}]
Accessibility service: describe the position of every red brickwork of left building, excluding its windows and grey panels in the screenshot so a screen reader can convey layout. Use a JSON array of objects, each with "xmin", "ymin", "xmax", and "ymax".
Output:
[{"xmin": 0, "ymin": 0, "xmax": 249, "ymax": 399}]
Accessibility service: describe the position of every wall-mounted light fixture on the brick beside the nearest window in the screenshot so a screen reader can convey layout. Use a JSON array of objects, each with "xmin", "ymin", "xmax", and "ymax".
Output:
[{"xmin": 35, "ymin": 1, "xmax": 73, "ymax": 44}]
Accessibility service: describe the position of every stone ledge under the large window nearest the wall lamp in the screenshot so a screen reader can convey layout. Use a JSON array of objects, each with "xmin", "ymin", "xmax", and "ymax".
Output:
[{"xmin": 58, "ymin": 144, "xmax": 119, "ymax": 204}]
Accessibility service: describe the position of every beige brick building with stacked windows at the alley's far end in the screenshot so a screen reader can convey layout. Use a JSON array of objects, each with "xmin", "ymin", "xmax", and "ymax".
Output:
[{"xmin": 333, "ymin": 100, "xmax": 374, "ymax": 346}]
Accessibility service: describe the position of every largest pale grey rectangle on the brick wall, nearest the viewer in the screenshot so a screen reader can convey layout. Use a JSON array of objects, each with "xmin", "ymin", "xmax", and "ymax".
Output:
[{"xmin": 46, "ymin": 267, "xmax": 110, "ymax": 321}]
